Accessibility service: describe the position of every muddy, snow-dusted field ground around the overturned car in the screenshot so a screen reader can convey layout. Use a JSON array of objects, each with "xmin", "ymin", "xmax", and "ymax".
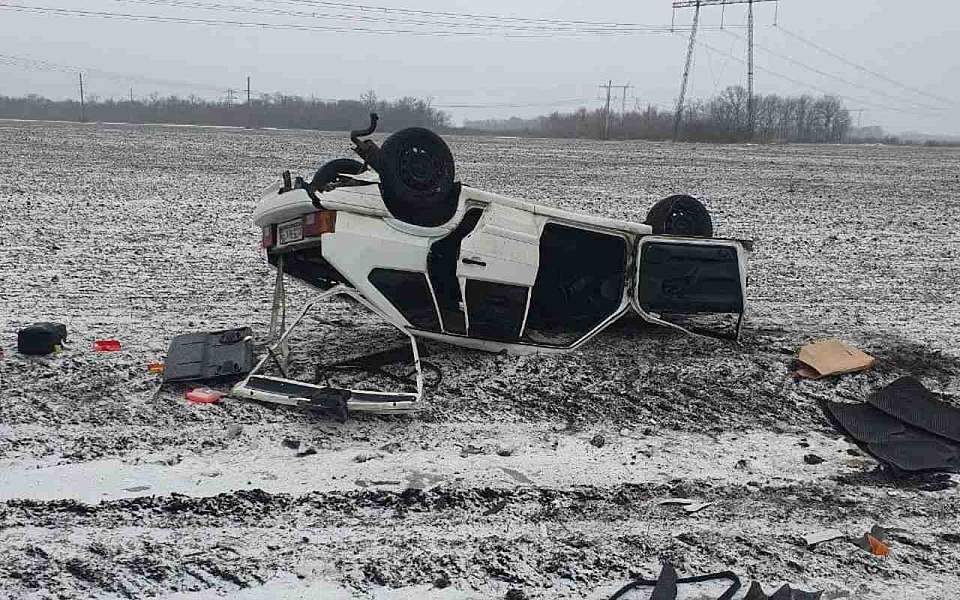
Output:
[{"xmin": 0, "ymin": 122, "xmax": 960, "ymax": 600}]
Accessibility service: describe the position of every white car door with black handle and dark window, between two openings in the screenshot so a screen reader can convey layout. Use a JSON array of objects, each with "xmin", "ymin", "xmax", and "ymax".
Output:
[{"xmin": 457, "ymin": 204, "xmax": 540, "ymax": 341}]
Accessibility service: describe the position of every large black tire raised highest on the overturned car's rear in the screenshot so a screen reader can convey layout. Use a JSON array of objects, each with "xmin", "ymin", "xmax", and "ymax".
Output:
[{"xmin": 373, "ymin": 127, "xmax": 460, "ymax": 227}]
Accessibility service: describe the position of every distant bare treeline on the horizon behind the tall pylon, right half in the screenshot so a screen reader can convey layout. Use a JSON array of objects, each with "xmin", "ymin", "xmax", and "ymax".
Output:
[{"xmin": 466, "ymin": 86, "xmax": 851, "ymax": 142}]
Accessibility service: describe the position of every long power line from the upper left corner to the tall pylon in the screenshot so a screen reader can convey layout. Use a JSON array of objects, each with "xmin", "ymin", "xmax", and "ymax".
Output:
[{"xmin": 0, "ymin": 0, "xmax": 748, "ymax": 39}]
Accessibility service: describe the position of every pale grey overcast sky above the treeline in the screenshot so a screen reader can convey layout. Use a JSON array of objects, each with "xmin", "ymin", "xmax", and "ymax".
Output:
[{"xmin": 0, "ymin": 0, "xmax": 960, "ymax": 134}]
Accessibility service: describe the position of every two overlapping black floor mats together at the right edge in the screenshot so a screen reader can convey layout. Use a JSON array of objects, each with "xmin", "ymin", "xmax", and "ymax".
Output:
[{"xmin": 822, "ymin": 377, "xmax": 960, "ymax": 473}]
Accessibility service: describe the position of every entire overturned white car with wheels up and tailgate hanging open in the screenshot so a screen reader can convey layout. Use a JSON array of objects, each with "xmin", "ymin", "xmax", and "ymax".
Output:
[{"xmin": 234, "ymin": 115, "xmax": 747, "ymax": 418}]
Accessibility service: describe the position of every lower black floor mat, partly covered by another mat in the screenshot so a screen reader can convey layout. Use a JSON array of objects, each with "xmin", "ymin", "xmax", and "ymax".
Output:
[{"xmin": 824, "ymin": 380, "xmax": 960, "ymax": 472}]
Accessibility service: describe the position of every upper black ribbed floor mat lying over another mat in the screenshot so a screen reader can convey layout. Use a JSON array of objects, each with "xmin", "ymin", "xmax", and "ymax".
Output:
[{"xmin": 869, "ymin": 377, "xmax": 960, "ymax": 443}]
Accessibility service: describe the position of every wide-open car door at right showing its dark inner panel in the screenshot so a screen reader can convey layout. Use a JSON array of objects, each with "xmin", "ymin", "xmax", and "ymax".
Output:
[{"xmin": 632, "ymin": 235, "xmax": 747, "ymax": 338}]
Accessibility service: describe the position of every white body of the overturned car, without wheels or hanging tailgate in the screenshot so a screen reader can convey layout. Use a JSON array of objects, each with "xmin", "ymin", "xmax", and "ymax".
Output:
[{"xmin": 254, "ymin": 171, "xmax": 746, "ymax": 353}]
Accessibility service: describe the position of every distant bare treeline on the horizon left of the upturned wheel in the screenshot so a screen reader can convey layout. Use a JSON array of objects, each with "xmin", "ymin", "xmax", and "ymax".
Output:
[{"xmin": 0, "ymin": 92, "xmax": 450, "ymax": 131}]
